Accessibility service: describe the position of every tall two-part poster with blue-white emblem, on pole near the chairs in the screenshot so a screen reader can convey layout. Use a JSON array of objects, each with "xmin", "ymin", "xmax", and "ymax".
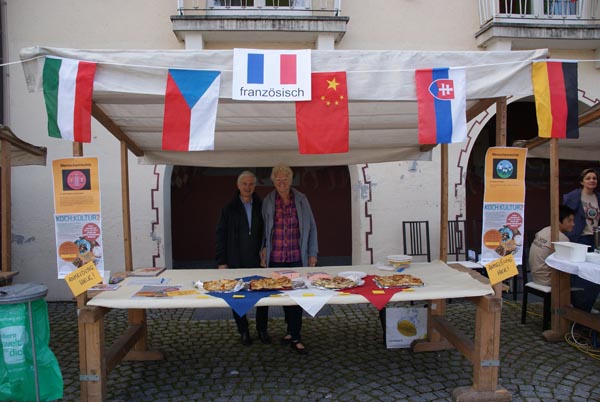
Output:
[{"xmin": 481, "ymin": 147, "xmax": 527, "ymax": 265}]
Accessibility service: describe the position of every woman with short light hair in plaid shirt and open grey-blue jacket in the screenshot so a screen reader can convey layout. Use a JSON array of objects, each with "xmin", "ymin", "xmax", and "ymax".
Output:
[{"xmin": 261, "ymin": 165, "xmax": 318, "ymax": 354}]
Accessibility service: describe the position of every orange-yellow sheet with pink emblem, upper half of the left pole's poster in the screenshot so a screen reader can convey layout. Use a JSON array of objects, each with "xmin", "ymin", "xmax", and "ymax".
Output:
[{"xmin": 52, "ymin": 158, "xmax": 100, "ymax": 214}]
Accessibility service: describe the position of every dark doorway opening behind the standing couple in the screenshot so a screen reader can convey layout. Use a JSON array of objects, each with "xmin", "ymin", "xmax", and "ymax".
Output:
[{"xmin": 171, "ymin": 166, "xmax": 352, "ymax": 268}]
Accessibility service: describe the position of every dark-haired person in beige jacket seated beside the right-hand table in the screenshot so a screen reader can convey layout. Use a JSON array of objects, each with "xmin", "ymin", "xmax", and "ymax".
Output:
[{"xmin": 528, "ymin": 205, "xmax": 575, "ymax": 286}]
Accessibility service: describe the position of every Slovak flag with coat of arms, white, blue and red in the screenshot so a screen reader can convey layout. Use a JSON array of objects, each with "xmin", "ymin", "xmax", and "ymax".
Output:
[{"xmin": 415, "ymin": 68, "xmax": 467, "ymax": 144}]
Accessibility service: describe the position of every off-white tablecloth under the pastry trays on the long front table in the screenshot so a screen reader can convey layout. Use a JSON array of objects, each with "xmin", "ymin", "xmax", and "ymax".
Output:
[{"xmin": 88, "ymin": 261, "xmax": 493, "ymax": 309}]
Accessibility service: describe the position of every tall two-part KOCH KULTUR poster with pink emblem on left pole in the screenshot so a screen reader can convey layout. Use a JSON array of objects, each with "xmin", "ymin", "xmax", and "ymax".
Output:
[{"xmin": 52, "ymin": 158, "xmax": 104, "ymax": 279}]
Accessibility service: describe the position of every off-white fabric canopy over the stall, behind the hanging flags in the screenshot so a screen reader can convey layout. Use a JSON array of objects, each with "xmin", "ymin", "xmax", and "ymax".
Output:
[{"xmin": 21, "ymin": 47, "xmax": 547, "ymax": 167}]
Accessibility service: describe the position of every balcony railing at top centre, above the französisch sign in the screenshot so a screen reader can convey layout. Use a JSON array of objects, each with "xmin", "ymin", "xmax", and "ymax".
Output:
[{"xmin": 177, "ymin": 0, "xmax": 342, "ymax": 16}]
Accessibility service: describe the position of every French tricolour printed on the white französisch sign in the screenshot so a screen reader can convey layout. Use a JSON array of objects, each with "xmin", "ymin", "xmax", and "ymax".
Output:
[{"xmin": 246, "ymin": 53, "xmax": 298, "ymax": 85}]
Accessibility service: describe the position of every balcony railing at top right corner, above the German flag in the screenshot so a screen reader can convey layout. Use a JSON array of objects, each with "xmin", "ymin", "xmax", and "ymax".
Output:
[{"xmin": 479, "ymin": 0, "xmax": 600, "ymax": 26}]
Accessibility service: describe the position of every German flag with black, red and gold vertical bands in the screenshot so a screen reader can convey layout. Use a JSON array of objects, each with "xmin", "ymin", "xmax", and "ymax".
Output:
[{"xmin": 531, "ymin": 61, "xmax": 579, "ymax": 138}]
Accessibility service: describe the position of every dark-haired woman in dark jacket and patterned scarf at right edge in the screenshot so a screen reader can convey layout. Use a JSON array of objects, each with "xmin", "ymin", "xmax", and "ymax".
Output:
[{"xmin": 563, "ymin": 169, "xmax": 600, "ymax": 312}]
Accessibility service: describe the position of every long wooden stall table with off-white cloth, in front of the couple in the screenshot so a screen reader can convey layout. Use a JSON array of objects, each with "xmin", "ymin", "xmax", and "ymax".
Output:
[{"xmin": 78, "ymin": 261, "xmax": 511, "ymax": 402}]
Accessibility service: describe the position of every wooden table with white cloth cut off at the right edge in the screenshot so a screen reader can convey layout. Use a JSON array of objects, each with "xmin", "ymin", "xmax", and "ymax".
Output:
[{"xmin": 543, "ymin": 254, "xmax": 600, "ymax": 342}]
